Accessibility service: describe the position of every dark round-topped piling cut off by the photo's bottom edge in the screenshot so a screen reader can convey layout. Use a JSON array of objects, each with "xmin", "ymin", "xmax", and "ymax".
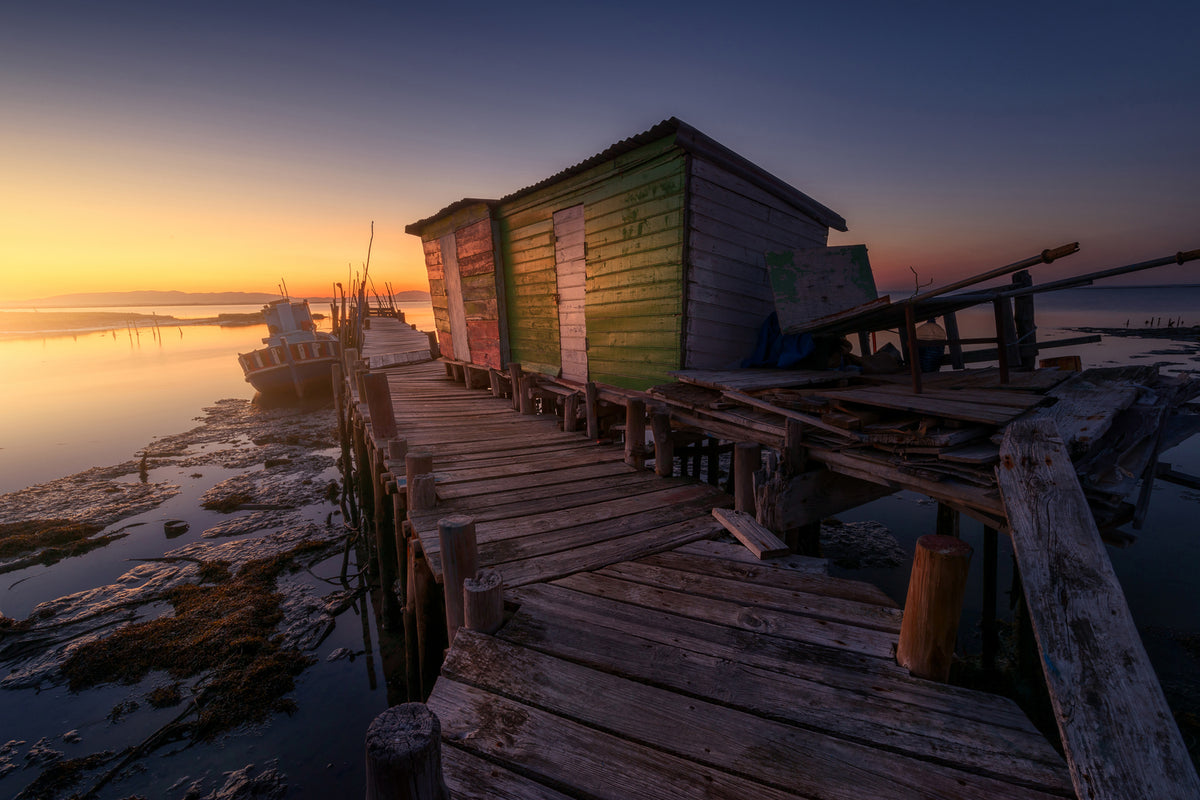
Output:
[{"xmin": 366, "ymin": 703, "xmax": 450, "ymax": 800}]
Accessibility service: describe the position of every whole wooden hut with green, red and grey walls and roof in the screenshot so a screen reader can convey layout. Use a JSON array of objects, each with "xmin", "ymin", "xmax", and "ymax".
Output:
[{"xmin": 406, "ymin": 118, "xmax": 846, "ymax": 389}]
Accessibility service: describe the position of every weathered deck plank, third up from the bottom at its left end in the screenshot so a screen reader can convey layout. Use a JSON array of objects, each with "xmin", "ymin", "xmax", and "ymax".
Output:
[{"xmin": 443, "ymin": 633, "xmax": 1070, "ymax": 800}]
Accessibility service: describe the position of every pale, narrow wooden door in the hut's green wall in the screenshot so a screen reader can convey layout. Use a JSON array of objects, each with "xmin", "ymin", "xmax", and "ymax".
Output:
[{"xmin": 554, "ymin": 205, "xmax": 588, "ymax": 381}]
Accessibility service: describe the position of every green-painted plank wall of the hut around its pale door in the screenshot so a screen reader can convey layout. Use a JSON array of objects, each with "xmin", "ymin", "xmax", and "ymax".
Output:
[{"xmin": 494, "ymin": 137, "xmax": 686, "ymax": 389}]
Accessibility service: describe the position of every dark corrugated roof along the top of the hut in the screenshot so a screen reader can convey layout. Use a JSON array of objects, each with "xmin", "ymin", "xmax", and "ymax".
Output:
[{"xmin": 404, "ymin": 116, "xmax": 846, "ymax": 235}]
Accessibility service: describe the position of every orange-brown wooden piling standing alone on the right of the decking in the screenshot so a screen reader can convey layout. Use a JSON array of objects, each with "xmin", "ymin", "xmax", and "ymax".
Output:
[{"xmin": 896, "ymin": 535, "xmax": 971, "ymax": 682}]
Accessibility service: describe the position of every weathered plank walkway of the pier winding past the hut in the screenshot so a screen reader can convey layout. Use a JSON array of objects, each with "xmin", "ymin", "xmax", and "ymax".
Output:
[{"xmin": 362, "ymin": 320, "xmax": 1074, "ymax": 799}]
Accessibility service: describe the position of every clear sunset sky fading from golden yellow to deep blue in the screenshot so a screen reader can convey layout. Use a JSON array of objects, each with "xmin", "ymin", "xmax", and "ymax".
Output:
[{"xmin": 0, "ymin": 0, "xmax": 1200, "ymax": 303}]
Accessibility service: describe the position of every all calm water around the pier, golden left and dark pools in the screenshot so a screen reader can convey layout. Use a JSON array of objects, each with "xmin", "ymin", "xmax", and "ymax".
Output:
[{"xmin": 0, "ymin": 288, "xmax": 1200, "ymax": 796}]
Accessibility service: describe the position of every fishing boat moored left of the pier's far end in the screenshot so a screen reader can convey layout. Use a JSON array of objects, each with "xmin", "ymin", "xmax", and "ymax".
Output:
[{"xmin": 238, "ymin": 297, "xmax": 340, "ymax": 397}]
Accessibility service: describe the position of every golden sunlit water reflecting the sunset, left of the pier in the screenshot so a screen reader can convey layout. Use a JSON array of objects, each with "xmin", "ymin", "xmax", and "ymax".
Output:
[{"xmin": 0, "ymin": 303, "xmax": 433, "ymax": 494}]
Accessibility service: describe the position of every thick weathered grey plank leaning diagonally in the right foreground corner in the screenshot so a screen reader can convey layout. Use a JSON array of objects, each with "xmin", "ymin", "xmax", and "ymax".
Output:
[{"xmin": 996, "ymin": 417, "xmax": 1200, "ymax": 800}]
